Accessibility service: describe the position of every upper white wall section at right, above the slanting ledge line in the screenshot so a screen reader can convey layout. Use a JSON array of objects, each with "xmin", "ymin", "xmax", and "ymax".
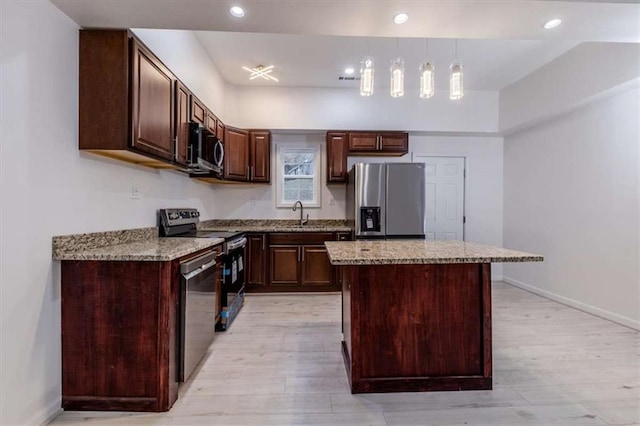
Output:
[{"xmin": 500, "ymin": 43, "xmax": 640, "ymax": 132}]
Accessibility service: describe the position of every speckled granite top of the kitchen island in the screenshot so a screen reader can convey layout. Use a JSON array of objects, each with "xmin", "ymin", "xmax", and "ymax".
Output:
[{"xmin": 325, "ymin": 240, "xmax": 543, "ymax": 265}]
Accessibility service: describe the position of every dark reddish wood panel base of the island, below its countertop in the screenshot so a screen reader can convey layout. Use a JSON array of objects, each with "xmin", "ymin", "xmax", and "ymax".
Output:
[{"xmin": 343, "ymin": 264, "xmax": 491, "ymax": 393}]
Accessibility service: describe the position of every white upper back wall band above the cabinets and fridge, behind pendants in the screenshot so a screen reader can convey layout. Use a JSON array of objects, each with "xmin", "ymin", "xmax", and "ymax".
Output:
[{"xmin": 236, "ymin": 86, "xmax": 498, "ymax": 132}]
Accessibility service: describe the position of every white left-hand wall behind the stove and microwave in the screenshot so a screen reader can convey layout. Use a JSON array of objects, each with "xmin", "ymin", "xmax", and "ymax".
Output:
[{"xmin": 0, "ymin": 0, "xmax": 228, "ymax": 425}]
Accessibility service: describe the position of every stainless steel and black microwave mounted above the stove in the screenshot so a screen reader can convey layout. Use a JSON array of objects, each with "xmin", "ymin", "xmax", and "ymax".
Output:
[{"xmin": 187, "ymin": 122, "xmax": 224, "ymax": 177}]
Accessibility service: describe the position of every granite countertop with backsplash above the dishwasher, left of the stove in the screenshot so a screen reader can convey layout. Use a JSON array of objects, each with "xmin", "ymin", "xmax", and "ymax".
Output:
[{"xmin": 53, "ymin": 228, "xmax": 224, "ymax": 261}]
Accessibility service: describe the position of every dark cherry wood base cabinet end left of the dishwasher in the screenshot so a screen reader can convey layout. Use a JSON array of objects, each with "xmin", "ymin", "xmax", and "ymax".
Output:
[{"xmin": 61, "ymin": 261, "xmax": 179, "ymax": 411}]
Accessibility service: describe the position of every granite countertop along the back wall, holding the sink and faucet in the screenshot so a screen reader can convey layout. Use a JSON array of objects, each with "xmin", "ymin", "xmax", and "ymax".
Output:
[{"xmin": 198, "ymin": 219, "xmax": 351, "ymax": 232}]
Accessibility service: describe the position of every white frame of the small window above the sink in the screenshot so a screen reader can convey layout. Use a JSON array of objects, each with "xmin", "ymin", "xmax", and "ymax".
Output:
[{"xmin": 276, "ymin": 144, "xmax": 322, "ymax": 208}]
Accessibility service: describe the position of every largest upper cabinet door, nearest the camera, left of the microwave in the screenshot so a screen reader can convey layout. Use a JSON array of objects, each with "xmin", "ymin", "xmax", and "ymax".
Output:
[{"xmin": 131, "ymin": 39, "xmax": 175, "ymax": 160}]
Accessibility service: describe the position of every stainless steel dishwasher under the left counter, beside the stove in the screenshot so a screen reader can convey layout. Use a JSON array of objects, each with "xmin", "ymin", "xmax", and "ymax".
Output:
[{"xmin": 178, "ymin": 250, "xmax": 218, "ymax": 382}]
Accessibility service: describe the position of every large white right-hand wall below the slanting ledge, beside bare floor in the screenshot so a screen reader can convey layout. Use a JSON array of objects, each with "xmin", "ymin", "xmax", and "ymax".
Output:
[{"xmin": 504, "ymin": 85, "xmax": 640, "ymax": 328}]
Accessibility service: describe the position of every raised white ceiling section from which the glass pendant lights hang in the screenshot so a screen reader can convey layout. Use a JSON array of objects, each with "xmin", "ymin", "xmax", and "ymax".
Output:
[{"xmin": 192, "ymin": 31, "xmax": 576, "ymax": 90}]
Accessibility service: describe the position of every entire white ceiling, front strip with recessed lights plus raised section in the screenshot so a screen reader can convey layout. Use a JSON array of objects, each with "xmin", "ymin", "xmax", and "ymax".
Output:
[{"xmin": 51, "ymin": 0, "xmax": 640, "ymax": 90}]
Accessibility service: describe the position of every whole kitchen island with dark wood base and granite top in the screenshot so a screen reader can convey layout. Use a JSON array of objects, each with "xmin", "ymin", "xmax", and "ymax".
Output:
[{"xmin": 325, "ymin": 240, "xmax": 543, "ymax": 393}]
